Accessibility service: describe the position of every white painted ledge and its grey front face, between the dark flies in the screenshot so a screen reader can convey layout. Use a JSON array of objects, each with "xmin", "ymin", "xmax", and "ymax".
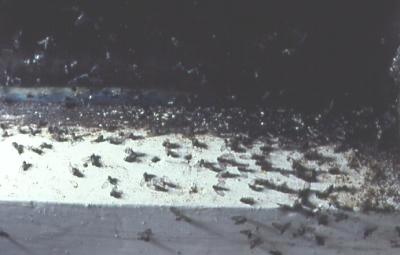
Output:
[{"xmin": 0, "ymin": 127, "xmax": 400, "ymax": 255}]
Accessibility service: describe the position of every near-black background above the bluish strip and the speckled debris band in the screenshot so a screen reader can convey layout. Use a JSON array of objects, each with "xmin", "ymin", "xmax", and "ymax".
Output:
[{"xmin": 0, "ymin": 0, "xmax": 400, "ymax": 111}]
